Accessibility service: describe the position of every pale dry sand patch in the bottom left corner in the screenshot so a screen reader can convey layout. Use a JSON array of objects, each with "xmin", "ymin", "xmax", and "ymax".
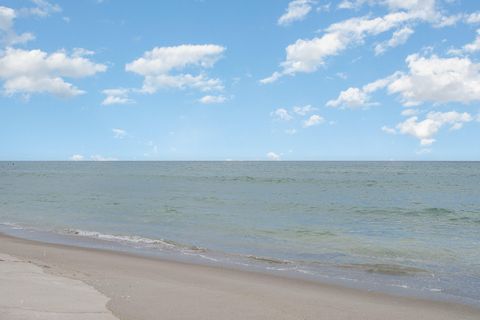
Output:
[{"xmin": 0, "ymin": 253, "xmax": 117, "ymax": 320}]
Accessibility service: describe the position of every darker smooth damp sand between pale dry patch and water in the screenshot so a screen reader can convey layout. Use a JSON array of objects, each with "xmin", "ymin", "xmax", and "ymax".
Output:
[{"xmin": 0, "ymin": 234, "xmax": 480, "ymax": 320}]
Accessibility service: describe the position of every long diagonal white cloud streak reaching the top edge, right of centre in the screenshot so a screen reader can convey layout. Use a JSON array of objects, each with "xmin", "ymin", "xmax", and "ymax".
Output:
[{"xmin": 260, "ymin": 0, "xmax": 452, "ymax": 84}]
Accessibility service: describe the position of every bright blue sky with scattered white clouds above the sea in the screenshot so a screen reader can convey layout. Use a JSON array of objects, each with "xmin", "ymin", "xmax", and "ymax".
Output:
[{"xmin": 0, "ymin": 0, "xmax": 480, "ymax": 161}]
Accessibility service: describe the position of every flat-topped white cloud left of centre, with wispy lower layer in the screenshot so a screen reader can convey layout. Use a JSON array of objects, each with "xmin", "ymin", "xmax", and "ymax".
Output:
[{"xmin": 125, "ymin": 44, "xmax": 225, "ymax": 93}]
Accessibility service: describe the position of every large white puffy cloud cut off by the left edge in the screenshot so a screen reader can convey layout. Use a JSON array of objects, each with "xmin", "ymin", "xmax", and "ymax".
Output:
[{"xmin": 0, "ymin": 47, "xmax": 107, "ymax": 97}]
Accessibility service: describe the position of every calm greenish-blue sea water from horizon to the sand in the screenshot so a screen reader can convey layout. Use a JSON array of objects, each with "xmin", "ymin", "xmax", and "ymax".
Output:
[{"xmin": 0, "ymin": 162, "xmax": 480, "ymax": 306}]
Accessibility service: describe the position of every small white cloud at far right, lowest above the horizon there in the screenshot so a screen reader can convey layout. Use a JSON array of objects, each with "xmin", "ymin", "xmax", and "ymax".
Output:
[{"xmin": 397, "ymin": 111, "xmax": 473, "ymax": 146}]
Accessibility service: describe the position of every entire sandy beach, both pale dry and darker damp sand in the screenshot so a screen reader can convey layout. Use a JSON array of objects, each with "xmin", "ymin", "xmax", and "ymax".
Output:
[{"xmin": 0, "ymin": 235, "xmax": 480, "ymax": 320}]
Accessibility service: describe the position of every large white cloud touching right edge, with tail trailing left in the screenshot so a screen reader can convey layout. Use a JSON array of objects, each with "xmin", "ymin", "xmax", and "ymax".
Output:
[{"xmin": 327, "ymin": 54, "xmax": 480, "ymax": 107}]
